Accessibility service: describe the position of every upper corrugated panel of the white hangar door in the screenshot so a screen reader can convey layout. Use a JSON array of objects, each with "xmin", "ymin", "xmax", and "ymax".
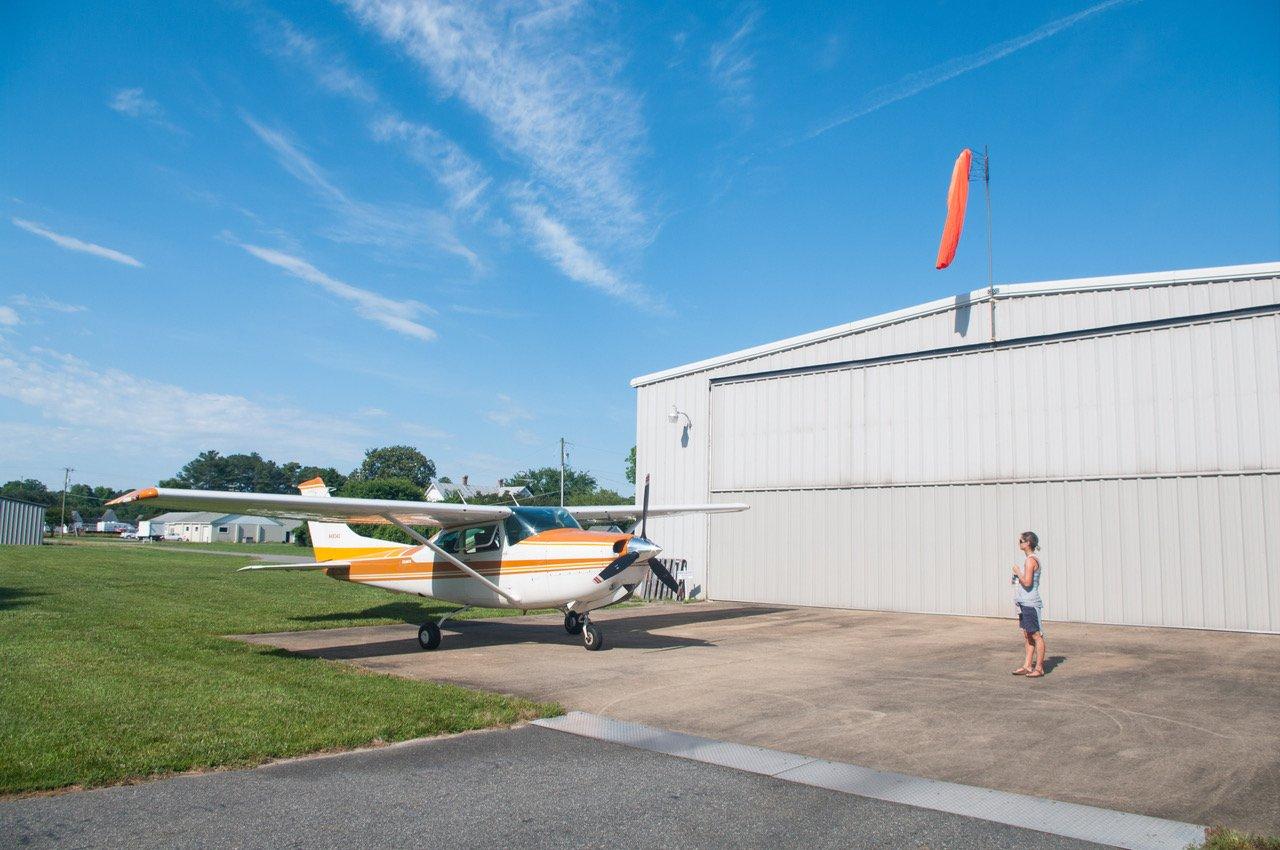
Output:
[{"xmin": 710, "ymin": 312, "xmax": 1280, "ymax": 492}]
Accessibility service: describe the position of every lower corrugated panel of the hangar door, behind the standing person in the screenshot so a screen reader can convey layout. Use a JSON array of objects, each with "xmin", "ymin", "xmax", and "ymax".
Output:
[{"xmin": 708, "ymin": 474, "xmax": 1280, "ymax": 632}]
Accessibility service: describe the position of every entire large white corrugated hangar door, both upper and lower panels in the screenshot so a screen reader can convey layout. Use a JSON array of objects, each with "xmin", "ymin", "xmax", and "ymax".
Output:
[{"xmin": 708, "ymin": 309, "xmax": 1280, "ymax": 631}]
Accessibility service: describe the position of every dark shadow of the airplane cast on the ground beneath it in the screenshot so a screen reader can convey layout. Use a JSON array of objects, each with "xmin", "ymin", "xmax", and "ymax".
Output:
[{"xmin": 271, "ymin": 605, "xmax": 790, "ymax": 661}]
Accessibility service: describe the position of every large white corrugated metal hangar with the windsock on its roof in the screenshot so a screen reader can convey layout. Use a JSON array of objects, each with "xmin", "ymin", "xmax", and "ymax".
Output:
[{"xmin": 631, "ymin": 262, "xmax": 1280, "ymax": 632}]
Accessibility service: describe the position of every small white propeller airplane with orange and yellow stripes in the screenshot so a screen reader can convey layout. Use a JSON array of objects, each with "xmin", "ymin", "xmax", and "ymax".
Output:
[{"xmin": 109, "ymin": 475, "xmax": 748, "ymax": 650}]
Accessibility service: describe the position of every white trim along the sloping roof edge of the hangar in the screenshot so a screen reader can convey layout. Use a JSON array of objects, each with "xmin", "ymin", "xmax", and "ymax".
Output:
[{"xmin": 631, "ymin": 261, "xmax": 1280, "ymax": 388}]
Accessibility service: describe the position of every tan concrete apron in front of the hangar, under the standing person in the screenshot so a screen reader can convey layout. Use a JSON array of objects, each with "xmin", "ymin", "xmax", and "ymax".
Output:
[{"xmin": 243, "ymin": 603, "xmax": 1280, "ymax": 833}]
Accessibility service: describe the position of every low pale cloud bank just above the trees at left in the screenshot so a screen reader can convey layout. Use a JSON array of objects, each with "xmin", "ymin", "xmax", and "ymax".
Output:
[{"xmin": 0, "ymin": 348, "xmax": 367, "ymax": 468}]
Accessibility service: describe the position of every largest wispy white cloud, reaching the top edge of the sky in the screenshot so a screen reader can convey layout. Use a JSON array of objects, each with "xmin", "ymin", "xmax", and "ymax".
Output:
[{"xmin": 347, "ymin": 0, "xmax": 652, "ymax": 302}]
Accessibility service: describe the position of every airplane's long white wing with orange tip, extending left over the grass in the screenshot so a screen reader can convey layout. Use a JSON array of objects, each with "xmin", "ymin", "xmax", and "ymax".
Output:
[{"xmin": 108, "ymin": 486, "xmax": 511, "ymax": 526}]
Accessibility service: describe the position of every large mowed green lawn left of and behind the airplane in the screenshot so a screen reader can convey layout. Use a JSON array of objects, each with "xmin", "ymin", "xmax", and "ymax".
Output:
[{"xmin": 0, "ymin": 545, "xmax": 561, "ymax": 794}]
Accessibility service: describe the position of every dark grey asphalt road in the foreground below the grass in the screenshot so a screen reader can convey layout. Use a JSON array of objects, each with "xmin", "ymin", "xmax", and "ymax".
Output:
[{"xmin": 0, "ymin": 726, "xmax": 1097, "ymax": 850}]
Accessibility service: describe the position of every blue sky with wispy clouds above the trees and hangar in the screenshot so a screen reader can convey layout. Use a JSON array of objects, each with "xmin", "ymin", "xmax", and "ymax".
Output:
[{"xmin": 0, "ymin": 0, "xmax": 1280, "ymax": 493}]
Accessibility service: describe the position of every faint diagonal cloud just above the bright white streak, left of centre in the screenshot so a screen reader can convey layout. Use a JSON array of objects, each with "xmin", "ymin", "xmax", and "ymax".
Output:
[{"xmin": 242, "ymin": 115, "xmax": 480, "ymax": 268}]
